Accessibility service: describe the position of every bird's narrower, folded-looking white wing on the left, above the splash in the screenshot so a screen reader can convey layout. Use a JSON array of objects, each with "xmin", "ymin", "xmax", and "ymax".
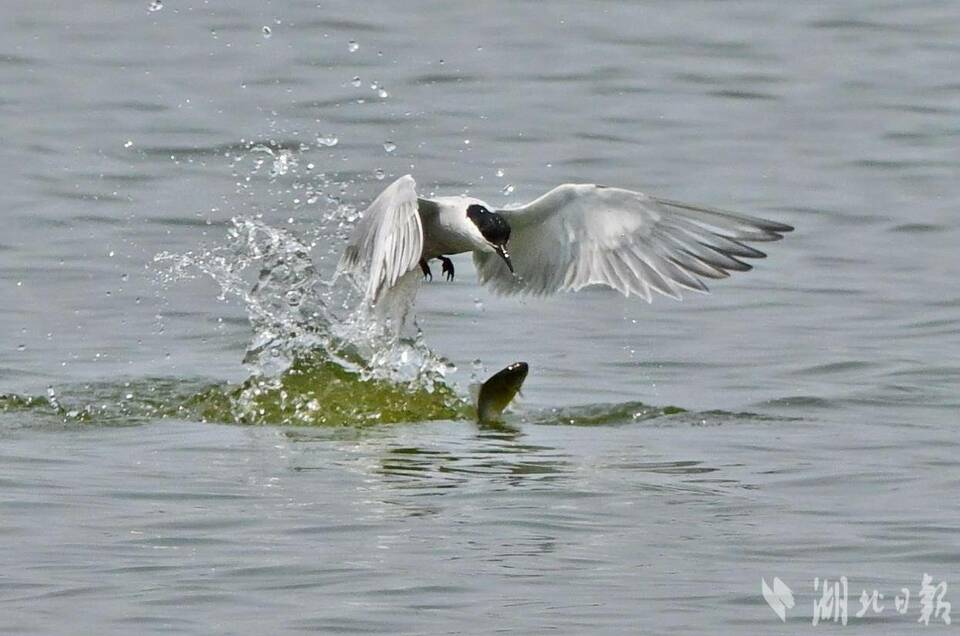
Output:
[{"xmin": 338, "ymin": 175, "xmax": 423, "ymax": 302}]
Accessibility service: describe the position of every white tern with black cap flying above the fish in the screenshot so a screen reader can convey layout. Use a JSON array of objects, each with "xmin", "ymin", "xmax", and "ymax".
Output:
[{"xmin": 338, "ymin": 175, "xmax": 793, "ymax": 304}]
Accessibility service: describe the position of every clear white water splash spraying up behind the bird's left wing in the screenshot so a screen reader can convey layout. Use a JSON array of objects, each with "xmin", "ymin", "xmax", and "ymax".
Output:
[{"xmin": 154, "ymin": 213, "xmax": 453, "ymax": 390}]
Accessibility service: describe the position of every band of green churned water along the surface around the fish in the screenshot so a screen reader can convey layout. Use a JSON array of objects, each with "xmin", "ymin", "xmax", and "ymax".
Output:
[{"xmin": 0, "ymin": 352, "xmax": 686, "ymax": 426}]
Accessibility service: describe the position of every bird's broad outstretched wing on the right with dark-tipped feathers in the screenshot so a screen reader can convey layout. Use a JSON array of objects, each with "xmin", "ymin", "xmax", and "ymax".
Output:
[{"xmin": 474, "ymin": 184, "xmax": 793, "ymax": 302}]
